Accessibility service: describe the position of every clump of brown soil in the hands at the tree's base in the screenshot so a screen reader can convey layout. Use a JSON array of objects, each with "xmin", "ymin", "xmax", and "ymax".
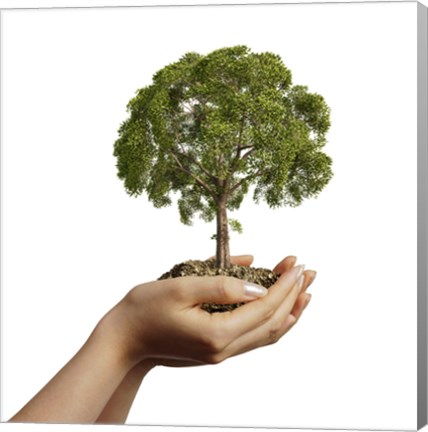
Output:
[{"xmin": 159, "ymin": 259, "xmax": 279, "ymax": 313}]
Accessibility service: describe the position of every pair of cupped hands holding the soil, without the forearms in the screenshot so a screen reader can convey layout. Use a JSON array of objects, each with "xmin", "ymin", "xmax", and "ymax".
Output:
[{"xmin": 107, "ymin": 255, "xmax": 316, "ymax": 366}]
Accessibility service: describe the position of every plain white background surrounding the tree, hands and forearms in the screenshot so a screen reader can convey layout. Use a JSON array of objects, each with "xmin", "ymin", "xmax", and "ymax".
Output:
[{"xmin": 1, "ymin": 3, "xmax": 417, "ymax": 429}]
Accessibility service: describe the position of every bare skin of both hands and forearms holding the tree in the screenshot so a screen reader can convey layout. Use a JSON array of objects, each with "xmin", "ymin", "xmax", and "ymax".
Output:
[{"xmin": 10, "ymin": 255, "xmax": 316, "ymax": 423}]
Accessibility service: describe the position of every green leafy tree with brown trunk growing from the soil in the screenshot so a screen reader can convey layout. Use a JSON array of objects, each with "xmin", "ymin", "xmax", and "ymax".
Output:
[{"xmin": 114, "ymin": 46, "xmax": 332, "ymax": 267}]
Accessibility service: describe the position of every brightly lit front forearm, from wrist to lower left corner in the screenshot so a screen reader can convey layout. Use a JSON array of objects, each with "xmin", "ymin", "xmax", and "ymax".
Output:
[{"xmin": 10, "ymin": 320, "xmax": 132, "ymax": 423}]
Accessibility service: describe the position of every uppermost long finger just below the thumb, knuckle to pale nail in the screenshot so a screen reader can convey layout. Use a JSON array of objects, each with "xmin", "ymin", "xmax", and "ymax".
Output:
[{"xmin": 213, "ymin": 266, "xmax": 303, "ymax": 340}]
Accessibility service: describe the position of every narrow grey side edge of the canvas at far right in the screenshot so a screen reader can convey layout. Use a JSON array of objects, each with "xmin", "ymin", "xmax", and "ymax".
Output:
[{"xmin": 417, "ymin": 3, "xmax": 428, "ymax": 430}]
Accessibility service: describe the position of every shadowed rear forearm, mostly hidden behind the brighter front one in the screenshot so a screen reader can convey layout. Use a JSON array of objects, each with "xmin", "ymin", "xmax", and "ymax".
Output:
[{"xmin": 96, "ymin": 361, "xmax": 154, "ymax": 424}]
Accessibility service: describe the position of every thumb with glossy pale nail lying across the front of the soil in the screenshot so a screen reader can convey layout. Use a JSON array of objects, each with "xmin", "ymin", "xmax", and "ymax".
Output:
[{"xmin": 181, "ymin": 276, "xmax": 268, "ymax": 306}]
